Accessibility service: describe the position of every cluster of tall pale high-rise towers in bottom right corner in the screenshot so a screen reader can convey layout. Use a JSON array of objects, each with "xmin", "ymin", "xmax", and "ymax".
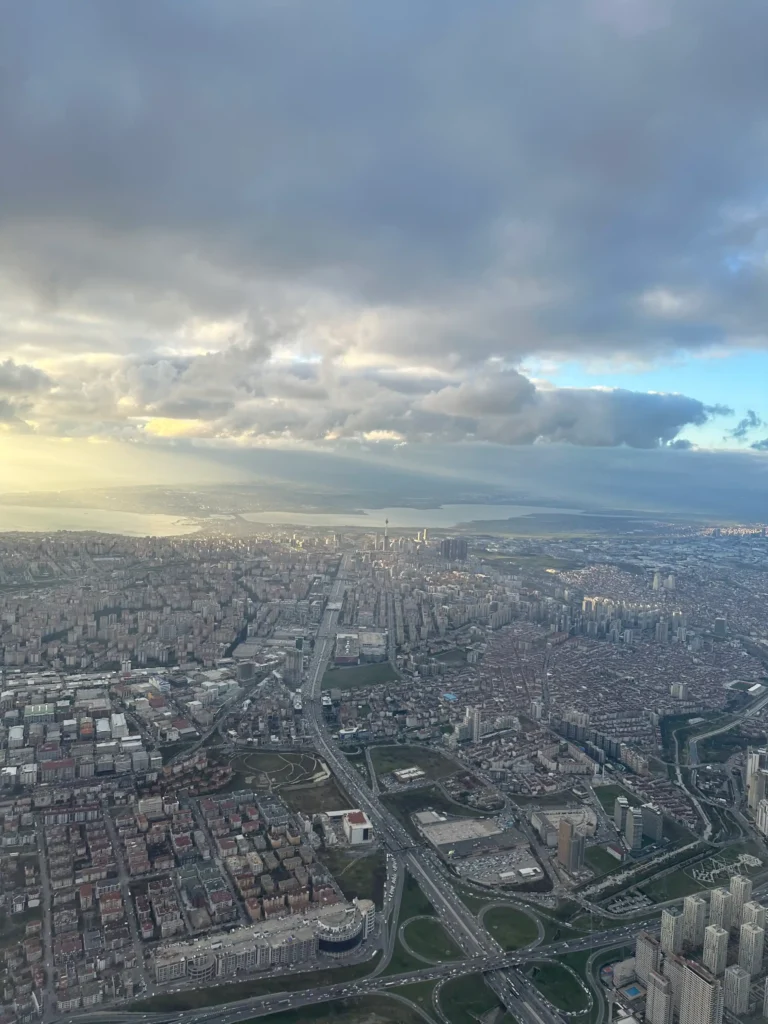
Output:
[{"xmin": 635, "ymin": 874, "xmax": 768, "ymax": 1024}]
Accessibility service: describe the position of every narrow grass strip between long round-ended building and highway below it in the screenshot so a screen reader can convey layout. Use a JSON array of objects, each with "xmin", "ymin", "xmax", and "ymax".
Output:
[{"xmin": 129, "ymin": 959, "xmax": 377, "ymax": 1014}]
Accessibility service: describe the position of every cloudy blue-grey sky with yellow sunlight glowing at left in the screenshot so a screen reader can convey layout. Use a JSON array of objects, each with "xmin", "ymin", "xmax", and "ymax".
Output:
[{"xmin": 0, "ymin": 0, "xmax": 768, "ymax": 488}]
